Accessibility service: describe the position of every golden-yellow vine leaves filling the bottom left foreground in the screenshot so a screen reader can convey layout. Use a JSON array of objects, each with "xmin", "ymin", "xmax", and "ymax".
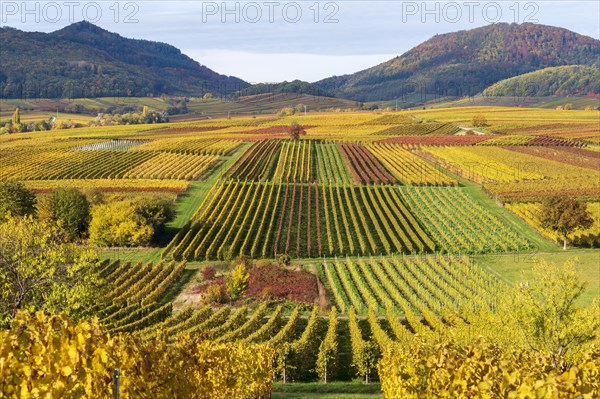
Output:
[{"xmin": 0, "ymin": 313, "xmax": 273, "ymax": 399}]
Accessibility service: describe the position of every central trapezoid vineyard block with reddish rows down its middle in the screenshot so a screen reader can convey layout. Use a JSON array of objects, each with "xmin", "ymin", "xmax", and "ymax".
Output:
[{"xmin": 163, "ymin": 180, "xmax": 435, "ymax": 260}]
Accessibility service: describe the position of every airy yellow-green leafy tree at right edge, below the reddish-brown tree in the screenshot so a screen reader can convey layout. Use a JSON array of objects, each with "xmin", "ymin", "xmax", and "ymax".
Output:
[{"xmin": 511, "ymin": 261, "xmax": 600, "ymax": 371}]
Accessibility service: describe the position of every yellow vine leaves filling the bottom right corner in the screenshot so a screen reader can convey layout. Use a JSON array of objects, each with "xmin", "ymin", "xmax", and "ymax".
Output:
[{"xmin": 378, "ymin": 340, "xmax": 600, "ymax": 399}]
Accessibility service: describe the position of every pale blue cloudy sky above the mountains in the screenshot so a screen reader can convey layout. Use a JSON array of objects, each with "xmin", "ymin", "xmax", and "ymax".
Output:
[{"xmin": 0, "ymin": 0, "xmax": 600, "ymax": 83}]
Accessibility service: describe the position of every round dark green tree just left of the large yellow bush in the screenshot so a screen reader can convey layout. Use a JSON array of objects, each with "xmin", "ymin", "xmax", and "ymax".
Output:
[{"xmin": 46, "ymin": 188, "xmax": 90, "ymax": 240}]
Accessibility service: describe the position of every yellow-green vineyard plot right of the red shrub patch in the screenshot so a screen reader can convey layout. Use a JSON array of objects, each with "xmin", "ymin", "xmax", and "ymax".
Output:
[{"xmin": 319, "ymin": 256, "xmax": 501, "ymax": 318}]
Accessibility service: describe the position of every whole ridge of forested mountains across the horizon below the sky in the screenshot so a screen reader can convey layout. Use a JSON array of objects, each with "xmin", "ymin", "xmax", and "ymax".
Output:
[{"xmin": 0, "ymin": 21, "xmax": 600, "ymax": 102}]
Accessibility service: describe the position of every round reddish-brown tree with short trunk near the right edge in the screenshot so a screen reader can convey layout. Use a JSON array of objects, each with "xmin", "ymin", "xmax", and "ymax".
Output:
[{"xmin": 539, "ymin": 197, "xmax": 594, "ymax": 250}]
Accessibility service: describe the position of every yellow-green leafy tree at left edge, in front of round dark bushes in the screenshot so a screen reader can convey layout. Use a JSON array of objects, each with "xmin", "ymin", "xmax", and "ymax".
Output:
[{"xmin": 0, "ymin": 216, "xmax": 98, "ymax": 323}]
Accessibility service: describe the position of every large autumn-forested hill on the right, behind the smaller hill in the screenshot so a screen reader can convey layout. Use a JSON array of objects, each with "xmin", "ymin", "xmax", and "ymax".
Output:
[{"xmin": 315, "ymin": 23, "xmax": 600, "ymax": 101}]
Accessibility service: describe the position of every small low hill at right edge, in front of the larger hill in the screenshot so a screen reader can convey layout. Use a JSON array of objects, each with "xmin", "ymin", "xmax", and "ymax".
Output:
[{"xmin": 483, "ymin": 65, "xmax": 600, "ymax": 97}]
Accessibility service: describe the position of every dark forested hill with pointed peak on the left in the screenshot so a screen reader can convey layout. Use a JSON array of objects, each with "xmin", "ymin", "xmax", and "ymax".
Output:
[{"xmin": 0, "ymin": 22, "xmax": 248, "ymax": 98}]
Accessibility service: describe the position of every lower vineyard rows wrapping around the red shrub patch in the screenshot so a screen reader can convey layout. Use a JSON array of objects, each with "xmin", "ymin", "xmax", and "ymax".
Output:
[{"xmin": 83, "ymin": 256, "xmax": 506, "ymax": 388}]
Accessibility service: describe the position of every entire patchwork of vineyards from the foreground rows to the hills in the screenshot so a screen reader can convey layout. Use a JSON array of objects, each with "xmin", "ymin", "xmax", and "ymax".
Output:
[{"xmin": 0, "ymin": 108, "xmax": 600, "ymax": 394}]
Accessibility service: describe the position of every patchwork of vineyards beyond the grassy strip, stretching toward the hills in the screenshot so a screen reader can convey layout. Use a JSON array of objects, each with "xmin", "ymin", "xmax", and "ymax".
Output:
[{"xmin": 0, "ymin": 108, "xmax": 600, "ymax": 261}]
